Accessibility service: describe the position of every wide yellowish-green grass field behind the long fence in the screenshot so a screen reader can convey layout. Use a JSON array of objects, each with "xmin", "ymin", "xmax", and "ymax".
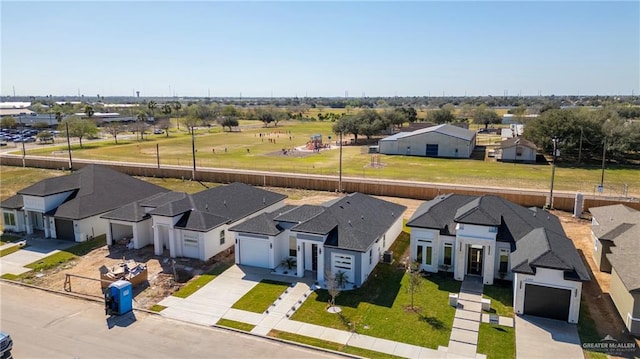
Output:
[{"xmin": 12, "ymin": 121, "xmax": 640, "ymax": 197}]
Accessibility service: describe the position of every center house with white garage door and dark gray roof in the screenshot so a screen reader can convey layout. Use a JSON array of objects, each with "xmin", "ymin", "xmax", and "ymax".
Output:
[{"xmin": 229, "ymin": 193, "xmax": 406, "ymax": 286}]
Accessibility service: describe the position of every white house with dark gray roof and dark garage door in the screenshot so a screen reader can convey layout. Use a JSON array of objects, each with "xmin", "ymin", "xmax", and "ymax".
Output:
[{"xmin": 407, "ymin": 194, "xmax": 590, "ymax": 323}]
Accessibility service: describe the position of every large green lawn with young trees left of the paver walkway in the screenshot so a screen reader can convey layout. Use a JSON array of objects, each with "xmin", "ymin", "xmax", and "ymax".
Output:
[{"xmin": 292, "ymin": 233, "xmax": 460, "ymax": 349}]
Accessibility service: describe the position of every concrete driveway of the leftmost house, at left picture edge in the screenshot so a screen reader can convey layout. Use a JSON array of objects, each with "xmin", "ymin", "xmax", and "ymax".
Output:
[{"xmin": 0, "ymin": 238, "xmax": 76, "ymax": 275}]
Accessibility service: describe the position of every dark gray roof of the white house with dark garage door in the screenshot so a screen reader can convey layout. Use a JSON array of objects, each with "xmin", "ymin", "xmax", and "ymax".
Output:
[{"xmin": 407, "ymin": 194, "xmax": 589, "ymax": 280}]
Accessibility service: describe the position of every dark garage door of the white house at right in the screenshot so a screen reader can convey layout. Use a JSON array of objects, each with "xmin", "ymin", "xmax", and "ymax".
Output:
[{"xmin": 524, "ymin": 284, "xmax": 571, "ymax": 321}]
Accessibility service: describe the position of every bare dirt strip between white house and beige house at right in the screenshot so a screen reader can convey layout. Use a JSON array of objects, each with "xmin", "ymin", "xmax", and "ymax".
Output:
[{"xmin": 551, "ymin": 211, "xmax": 640, "ymax": 354}]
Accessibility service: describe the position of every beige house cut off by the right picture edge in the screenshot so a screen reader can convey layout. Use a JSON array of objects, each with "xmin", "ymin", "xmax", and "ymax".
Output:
[{"xmin": 589, "ymin": 204, "xmax": 640, "ymax": 335}]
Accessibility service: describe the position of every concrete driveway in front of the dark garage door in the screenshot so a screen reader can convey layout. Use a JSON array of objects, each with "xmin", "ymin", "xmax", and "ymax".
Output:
[{"xmin": 515, "ymin": 315, "xmax": 584, "ymax": 359}]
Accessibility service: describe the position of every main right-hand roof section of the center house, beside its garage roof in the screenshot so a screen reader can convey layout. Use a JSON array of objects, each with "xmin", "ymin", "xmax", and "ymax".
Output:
[{"xmin": 291, "ymin": 192, "xmax": 406, "ymax": 252}]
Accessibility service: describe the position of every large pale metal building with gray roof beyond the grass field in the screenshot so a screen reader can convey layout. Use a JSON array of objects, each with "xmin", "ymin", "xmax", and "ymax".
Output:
[{"xmin": 378, "ymin": 124, "xmax": 476, "ymax": 158}]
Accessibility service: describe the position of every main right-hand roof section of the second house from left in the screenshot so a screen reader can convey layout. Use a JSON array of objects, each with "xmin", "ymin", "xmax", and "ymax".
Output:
[{"xmin": 149, "ymin": 182, "xmax": 287, "ymax": 232}]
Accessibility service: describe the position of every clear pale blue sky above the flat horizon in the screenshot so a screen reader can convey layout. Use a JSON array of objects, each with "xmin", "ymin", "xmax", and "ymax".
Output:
[{"xmin": 0, "ymin": 1, "xmax": 640, "ymax": 97}]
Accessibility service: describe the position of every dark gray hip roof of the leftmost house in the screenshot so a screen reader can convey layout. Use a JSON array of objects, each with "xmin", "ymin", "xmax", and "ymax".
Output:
[{"xmin": 18, "ymin": 165, "xmax": 168, "ymax": 219}]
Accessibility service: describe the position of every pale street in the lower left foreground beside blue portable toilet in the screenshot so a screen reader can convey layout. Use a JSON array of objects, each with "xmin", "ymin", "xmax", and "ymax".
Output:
[{"xmin": 0, "ymin": 282, "xmax": 339, "ymax": 359}]
